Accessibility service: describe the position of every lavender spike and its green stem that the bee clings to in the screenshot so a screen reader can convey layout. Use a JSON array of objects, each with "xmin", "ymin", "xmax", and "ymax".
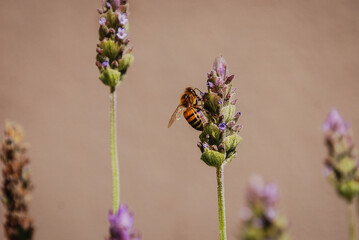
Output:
[{"xmin": 197, "ymin": 57, "xmax": 242, "ymax": 240}]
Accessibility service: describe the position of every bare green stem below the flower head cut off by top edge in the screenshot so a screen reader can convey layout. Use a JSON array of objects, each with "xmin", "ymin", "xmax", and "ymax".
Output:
[{"xmin": 110, "ymin": 89, "xmax": 120, "ymax": 214}]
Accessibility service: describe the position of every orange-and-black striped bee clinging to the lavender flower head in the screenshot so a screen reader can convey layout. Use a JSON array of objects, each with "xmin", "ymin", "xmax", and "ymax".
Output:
[{"xmin": 168, "ymin": 87, "xmax": 206, "ymax": 131}]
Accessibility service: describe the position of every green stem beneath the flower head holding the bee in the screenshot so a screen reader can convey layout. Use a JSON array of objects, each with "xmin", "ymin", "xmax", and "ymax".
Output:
[{"xmin": 217, "ymin": 165, "xmax": 227, "ymax": 240}]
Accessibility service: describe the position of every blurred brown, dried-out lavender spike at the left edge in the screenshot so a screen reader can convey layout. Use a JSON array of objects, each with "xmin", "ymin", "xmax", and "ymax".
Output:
[{"xmin": 0, "ymin": 122, "xmax": 34, "ymax": 240}]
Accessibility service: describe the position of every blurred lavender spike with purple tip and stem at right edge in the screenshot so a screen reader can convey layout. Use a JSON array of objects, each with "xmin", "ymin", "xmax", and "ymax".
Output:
[{"xmin": 323, "ymin": 109, "xmax": 359, "ymax": 240}]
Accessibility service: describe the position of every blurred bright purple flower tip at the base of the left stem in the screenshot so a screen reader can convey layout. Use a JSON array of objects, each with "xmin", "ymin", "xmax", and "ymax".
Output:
[{"xmin": 108, "ymin": 205, "xmax": 141, "ymax": 240}]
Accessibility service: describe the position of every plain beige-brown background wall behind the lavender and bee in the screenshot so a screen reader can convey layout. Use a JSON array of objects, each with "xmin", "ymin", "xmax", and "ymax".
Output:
[{"xmin": 0, "ymin": 0, "xmax": 359, "ymax": 240}]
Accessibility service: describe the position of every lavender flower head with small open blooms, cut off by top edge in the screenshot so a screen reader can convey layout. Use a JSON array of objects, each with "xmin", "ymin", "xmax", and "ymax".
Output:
[{"xmin": 96, "ymin": 0, "xmax": 133, "ymax": 90}]
